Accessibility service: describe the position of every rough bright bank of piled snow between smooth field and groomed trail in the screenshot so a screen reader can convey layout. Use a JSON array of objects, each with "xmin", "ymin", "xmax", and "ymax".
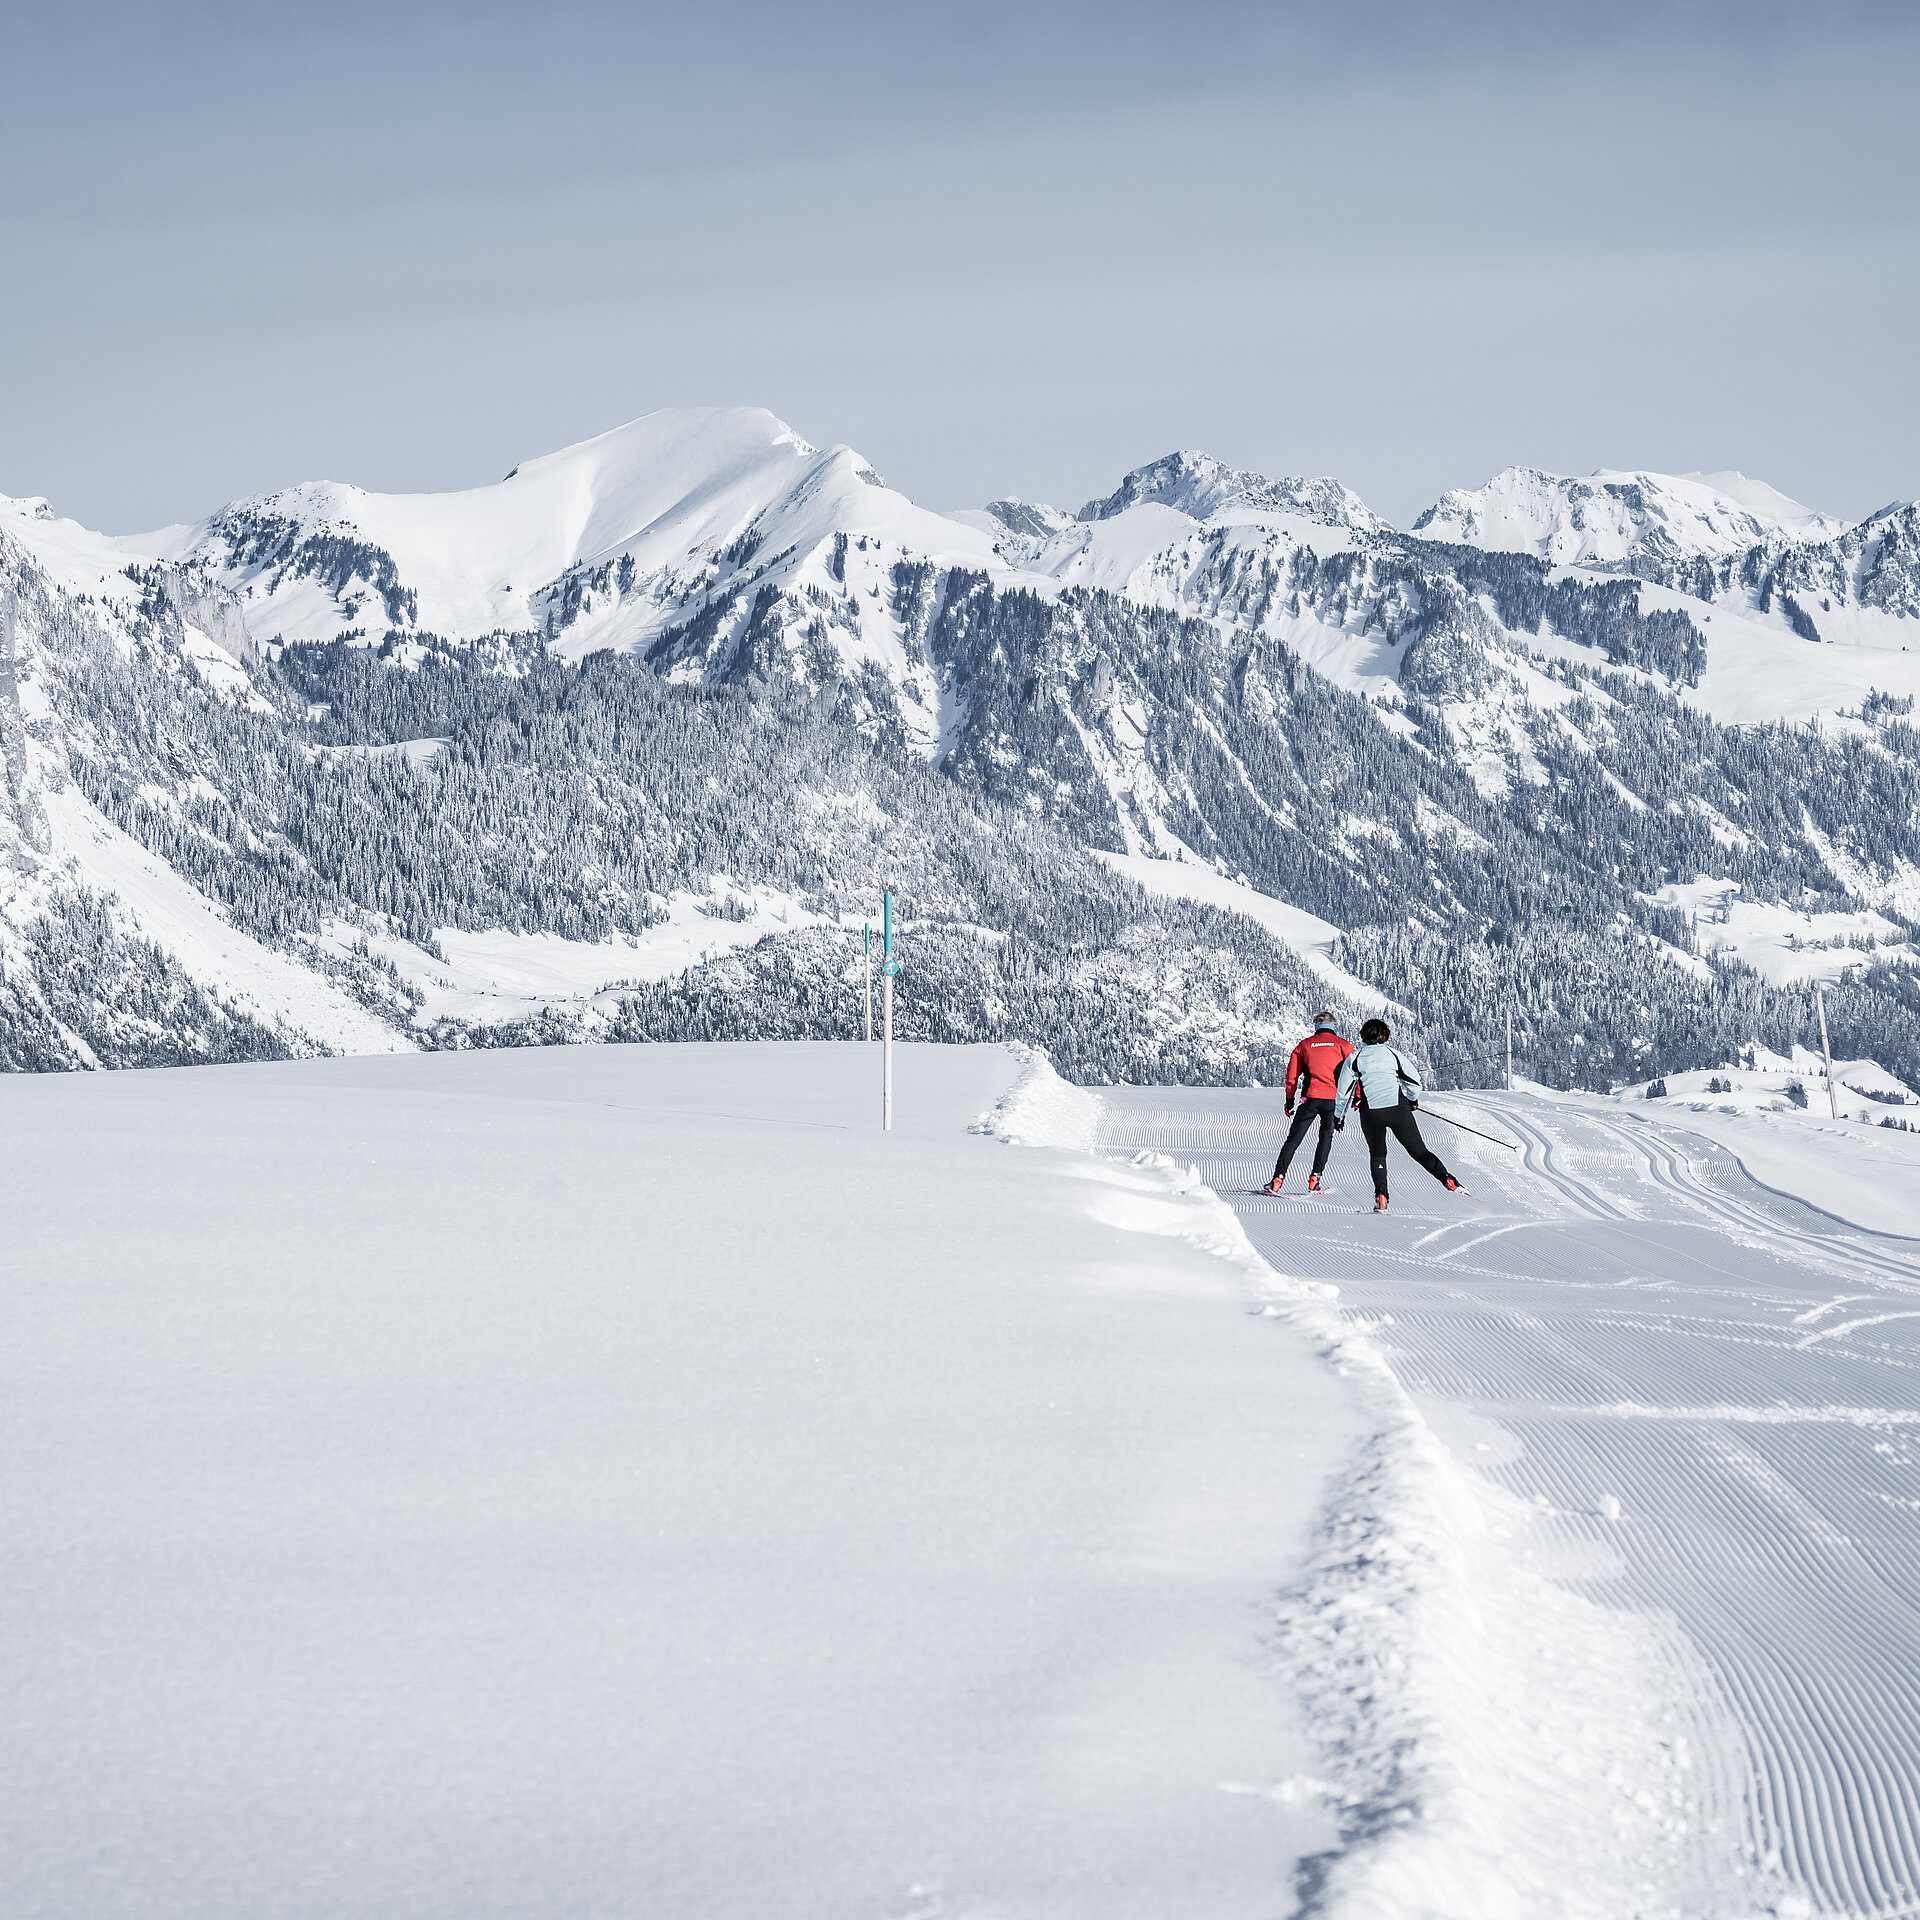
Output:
[{"xmin": 1269, "ymin": 1298, "xmax": 1738, "ymax": 1920}]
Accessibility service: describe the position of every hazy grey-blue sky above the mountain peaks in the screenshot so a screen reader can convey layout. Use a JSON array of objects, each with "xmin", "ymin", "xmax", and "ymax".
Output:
[{"xmin": 0, "ymin": 0, "xmax": 1920, "ymax": 532}]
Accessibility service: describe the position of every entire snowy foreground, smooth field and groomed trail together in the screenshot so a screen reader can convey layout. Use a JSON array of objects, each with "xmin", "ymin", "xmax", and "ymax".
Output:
[{"xmin": 18, "ymin": 1044, "xmax": 1920, "ymax": 1920}]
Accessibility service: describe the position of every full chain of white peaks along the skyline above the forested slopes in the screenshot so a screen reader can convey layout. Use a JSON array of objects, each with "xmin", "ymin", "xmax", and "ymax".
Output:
[{"xmin": 61, "ymin": 409, "xmax": 1920, "ymax": 748}]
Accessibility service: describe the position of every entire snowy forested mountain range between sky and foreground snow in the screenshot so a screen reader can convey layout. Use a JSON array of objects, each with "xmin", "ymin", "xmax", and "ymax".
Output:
[{"xmin": 0, "ymin": 409, "xmax": 1920, "ymax": 1089}]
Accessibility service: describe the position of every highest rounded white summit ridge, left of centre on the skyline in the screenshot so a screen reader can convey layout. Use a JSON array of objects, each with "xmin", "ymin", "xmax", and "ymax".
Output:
[{"xmin": 111, "ymin": 407, "xmax": 1004, "ymax": 675}]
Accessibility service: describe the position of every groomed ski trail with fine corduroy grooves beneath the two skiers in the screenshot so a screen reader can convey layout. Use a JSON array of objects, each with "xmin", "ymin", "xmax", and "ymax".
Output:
[{"xmin": 1102, "ymin": 1089, "xmax": 1920, "ymax": 1920}]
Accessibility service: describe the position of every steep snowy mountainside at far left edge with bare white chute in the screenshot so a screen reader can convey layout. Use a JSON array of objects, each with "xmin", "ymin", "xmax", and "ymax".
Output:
[{"xmin": 0, "ymin": 499, "xmax": 409, "ymax": 1068}]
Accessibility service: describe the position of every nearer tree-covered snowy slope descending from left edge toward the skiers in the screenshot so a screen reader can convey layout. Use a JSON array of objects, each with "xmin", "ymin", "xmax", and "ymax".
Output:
[{"xmin": 0, "ymin": 455, "xmax": 1327, "ymax": 1077}]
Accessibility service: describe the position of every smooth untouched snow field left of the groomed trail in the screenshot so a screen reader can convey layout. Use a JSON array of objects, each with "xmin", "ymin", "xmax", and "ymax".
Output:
[{"xmin": 0, "ymin": 1044, "xmax": 1361, "ymax": 1920}]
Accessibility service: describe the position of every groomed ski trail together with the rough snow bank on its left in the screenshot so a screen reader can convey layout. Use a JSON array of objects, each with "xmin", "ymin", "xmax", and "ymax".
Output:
[{"xmin": 1102, "ymin": 1089, "xmax": 1920, "ymax": 1920}]
